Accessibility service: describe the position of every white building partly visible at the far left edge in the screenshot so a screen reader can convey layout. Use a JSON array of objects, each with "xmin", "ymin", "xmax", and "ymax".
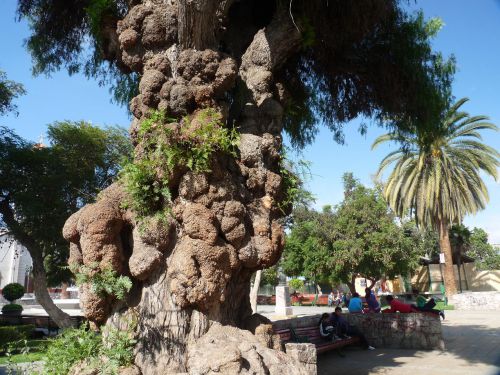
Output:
[{"xmin": 0, "ymin": 230, "xmax": 33, "ymax": 291}]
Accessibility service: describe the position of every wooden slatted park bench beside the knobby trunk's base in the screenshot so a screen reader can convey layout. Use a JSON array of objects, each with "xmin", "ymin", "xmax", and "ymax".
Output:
[{"xmin": 274, "ymin": 326, "xmax": 359, "ymax": 354}]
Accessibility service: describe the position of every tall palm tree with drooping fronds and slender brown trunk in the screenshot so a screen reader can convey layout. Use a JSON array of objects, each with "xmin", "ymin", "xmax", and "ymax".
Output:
[{"xmin": 372, "ymin": 98, "xmax": 500, "ymax": 296}]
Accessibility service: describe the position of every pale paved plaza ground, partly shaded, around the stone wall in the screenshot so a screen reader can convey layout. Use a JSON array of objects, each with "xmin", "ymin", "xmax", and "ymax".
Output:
[{"xmin": 259, "ymin": 306, "xmax": 500, "ymax": 375}]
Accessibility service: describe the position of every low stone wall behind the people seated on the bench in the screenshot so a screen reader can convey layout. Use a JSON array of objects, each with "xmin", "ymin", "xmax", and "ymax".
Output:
[{"xmin": 273, "ymin": 313, "xmax": 444, "ymax": 350}]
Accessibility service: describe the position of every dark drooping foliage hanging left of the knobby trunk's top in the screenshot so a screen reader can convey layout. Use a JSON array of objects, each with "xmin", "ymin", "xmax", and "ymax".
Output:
[{"xmin": 17, "ymin": 0, "xmax": 132, "ymax": 105}]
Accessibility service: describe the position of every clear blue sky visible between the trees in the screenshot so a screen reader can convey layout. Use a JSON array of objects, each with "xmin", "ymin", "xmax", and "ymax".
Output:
[{"xmin": 0, "ymin": 0, "xmax": 500, "ymax": 243}]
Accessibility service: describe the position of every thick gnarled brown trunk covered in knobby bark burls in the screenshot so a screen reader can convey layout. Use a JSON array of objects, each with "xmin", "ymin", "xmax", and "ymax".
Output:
[{"xmin": 63, "ymin": 0, "xmax": 306, "ymax": 375}]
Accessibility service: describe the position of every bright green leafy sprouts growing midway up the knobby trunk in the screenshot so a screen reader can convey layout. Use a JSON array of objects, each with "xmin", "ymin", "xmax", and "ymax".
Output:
[{"xmin": 121, "ymin": 108, "xmax": 239, "ymax": 218}]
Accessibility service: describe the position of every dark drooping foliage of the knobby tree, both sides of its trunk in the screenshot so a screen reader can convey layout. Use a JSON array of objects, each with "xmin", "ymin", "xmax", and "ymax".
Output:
[{"xmin": 17, "ymin": 0, "xmax": 455, "ymax": 143}]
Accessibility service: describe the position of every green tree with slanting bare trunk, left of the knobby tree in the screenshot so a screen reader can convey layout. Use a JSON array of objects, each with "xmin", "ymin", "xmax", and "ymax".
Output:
[{"xmin": 0, "ymin": 121, "xmax": 131, "ymax": 327}]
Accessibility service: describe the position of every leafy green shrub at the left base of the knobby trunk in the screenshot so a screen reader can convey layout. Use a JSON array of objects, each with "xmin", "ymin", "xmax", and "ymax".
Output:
[{"xmin": 43, "ymin": 324, "xmax": 136, "ymax": 375}]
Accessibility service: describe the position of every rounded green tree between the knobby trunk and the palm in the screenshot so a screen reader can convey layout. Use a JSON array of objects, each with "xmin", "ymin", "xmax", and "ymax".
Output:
[{"xmin": 283, "ymin": 174, "xmax": 425, "ymax": 290}]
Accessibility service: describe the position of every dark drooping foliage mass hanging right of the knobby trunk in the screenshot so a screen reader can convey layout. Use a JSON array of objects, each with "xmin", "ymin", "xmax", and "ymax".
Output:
[{"xmin": 281, "ymin": 4, "xmax": 455, "ymax": 148}]
